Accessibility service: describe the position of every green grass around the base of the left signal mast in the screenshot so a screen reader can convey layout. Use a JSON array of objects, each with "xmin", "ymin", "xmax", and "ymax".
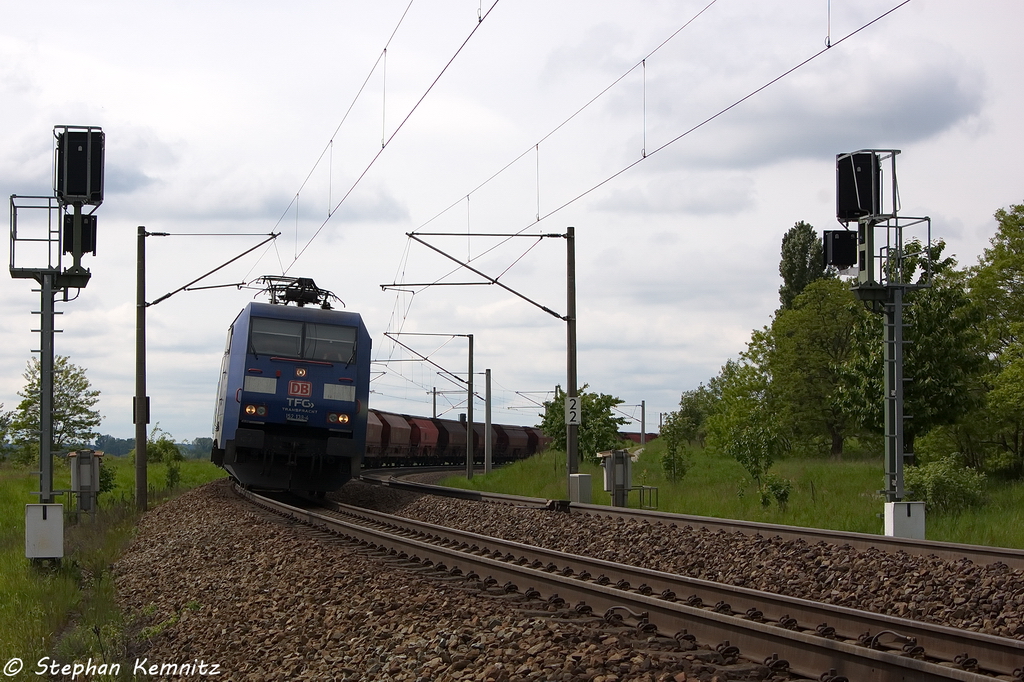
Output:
[{"xmin": 0, "ymin": 450, "xmax": 225, "ymax": 675}]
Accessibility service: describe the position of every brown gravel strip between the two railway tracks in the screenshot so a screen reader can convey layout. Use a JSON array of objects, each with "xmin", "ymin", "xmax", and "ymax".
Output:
[{"xmin": 333, "ymin": 481, "xmax": 1024, "ymax": 639}]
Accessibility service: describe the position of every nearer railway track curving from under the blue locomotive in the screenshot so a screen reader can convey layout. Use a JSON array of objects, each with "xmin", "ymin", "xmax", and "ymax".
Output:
[{"xmin": 240, "ymin": 483, "xmax": 1024, "ymax": 682}]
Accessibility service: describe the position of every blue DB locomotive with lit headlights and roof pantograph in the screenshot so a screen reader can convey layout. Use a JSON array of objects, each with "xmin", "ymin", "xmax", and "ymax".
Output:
[{"xmin": 212, "ymin": 278, "xmax": 371, "ymax": 494}]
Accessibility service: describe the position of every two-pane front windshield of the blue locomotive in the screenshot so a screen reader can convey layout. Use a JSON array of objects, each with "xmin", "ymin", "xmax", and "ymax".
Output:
[{"xmin": 249, "ymin": 317, "xmax": 356, "ymax": 365}]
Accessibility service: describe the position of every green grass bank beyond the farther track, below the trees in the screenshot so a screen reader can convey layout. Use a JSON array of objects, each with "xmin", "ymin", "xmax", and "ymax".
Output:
[{"xmin": 442, "ymin": 440, "xmax": 1024, "ymax": 549}]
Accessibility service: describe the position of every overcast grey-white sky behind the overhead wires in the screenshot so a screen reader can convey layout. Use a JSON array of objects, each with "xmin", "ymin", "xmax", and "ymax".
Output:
[{"xmin": 0, "ymin": 0, "xmax": 1024, "ymax": 439}]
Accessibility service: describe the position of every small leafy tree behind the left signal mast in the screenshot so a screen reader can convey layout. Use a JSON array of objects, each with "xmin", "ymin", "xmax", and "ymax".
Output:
[{"xmin": 11, "ymin": 355, "xmax": 102, "ymax": 453}]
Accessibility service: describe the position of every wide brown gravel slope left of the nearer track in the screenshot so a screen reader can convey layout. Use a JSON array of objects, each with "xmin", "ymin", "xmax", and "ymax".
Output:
[{"xmin": 115, "ymin": 480, "xmax": 769, "ymax": 682}]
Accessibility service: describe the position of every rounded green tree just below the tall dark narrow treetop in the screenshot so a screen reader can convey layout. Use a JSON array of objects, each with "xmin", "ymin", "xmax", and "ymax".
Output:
[{"xmin": 768, "ymin": 280, "xmax": 869, "ymax": 459}]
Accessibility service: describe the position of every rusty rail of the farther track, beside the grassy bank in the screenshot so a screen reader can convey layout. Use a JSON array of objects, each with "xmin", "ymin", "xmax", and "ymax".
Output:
[{"xmin": 360, "ymin": 468, "xmax": 1024, "ymax": 569}]
